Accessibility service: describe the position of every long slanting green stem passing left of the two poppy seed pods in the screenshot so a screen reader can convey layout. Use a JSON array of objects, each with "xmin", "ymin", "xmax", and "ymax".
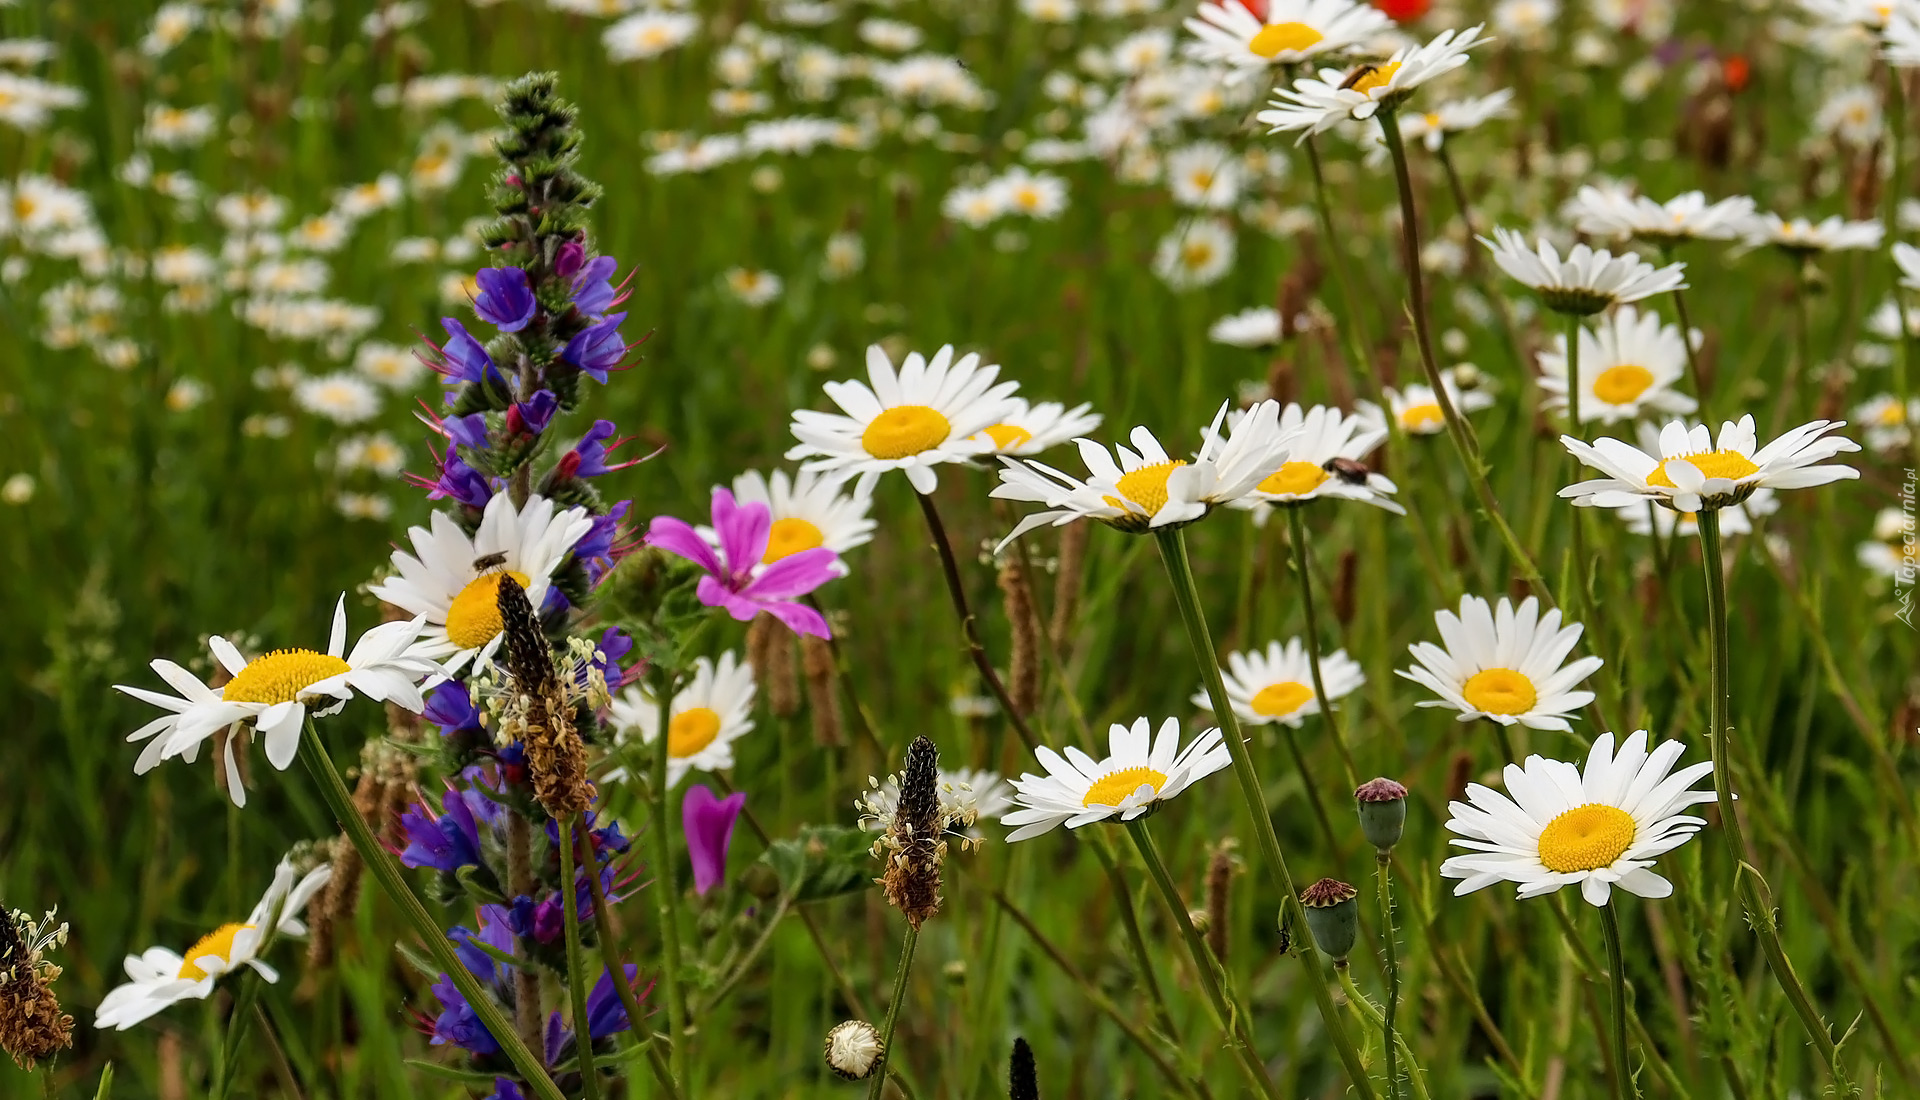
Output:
[{"xmin": 1154, "ymin": 528, "xmax": 1375, "ymax": 1100}]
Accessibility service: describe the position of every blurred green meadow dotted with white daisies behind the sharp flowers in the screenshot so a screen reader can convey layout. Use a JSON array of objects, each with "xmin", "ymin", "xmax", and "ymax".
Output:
[{"xmin": 0, "ymin": 0, "xmax": 1920, "ymax": 1098}]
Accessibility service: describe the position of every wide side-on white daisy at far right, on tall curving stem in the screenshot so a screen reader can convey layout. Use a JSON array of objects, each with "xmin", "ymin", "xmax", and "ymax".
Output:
[{"xmin": 1559, "ymin": 417, "xmax": 1860, "ymax": 513}]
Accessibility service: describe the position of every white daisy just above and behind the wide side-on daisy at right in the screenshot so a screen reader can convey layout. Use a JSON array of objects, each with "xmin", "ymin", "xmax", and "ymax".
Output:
[{"xmin": 1540, "ymin": 305, "xmax": 1697, "ymax": 424}]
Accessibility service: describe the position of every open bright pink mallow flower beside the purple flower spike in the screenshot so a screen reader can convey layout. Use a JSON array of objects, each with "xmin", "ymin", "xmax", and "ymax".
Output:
[{"xmin": 647, "ymin": 490, "xmax": 839, "ymax": 637}]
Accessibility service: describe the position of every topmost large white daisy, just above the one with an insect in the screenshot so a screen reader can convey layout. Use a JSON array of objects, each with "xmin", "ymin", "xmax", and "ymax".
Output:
[{"xmin": 1185, "ymin": 0, "xmax": 1394, "ymax": 79}]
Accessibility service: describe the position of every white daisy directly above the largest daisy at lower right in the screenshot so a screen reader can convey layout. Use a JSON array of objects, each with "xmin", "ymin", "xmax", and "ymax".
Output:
[{"xmin": 1394, "ymin": 595, "xmax": 1601, "ymax": 729}]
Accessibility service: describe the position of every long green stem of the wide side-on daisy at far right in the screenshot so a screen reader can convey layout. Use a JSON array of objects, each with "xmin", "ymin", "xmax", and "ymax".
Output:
[{"xmin": 1699, "ymin": 509, "xmax": 1853, "ymax": 1092}]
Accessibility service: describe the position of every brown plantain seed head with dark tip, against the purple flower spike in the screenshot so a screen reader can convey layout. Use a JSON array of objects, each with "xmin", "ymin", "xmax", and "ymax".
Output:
[{"xmin": 499, "ymin": 574, "xmax": 593, "ymax": 818}]
